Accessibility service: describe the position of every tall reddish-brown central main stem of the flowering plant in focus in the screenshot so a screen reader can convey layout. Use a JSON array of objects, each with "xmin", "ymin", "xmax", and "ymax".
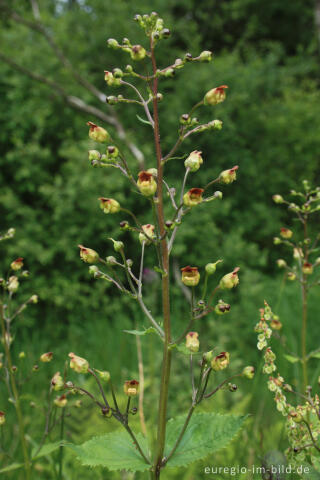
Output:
[{"xmin": 150, "ymin": 37, "xmax": 172, "ymax": 480}]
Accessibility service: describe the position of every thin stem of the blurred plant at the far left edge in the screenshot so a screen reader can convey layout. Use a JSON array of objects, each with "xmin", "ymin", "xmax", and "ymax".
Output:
[{"xmin": 0, "ymin": 302, "xmax": 31, "ymax": 480}]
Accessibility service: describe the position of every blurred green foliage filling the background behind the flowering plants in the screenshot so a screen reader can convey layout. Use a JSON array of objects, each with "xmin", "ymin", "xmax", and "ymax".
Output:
[{"xmin": 0, "ymin": 0, "xmax": 320, "ymax": 480}]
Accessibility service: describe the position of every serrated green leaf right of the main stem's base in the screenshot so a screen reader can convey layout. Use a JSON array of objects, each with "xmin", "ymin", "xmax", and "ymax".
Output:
[{"xmin": 165, "ymin": 413, "xmax": 246, "ymax": 467}]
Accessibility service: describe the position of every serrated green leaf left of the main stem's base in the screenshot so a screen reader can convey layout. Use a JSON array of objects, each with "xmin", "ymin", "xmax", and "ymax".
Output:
[{"xmin": 66, "ymin": 431, "xmax": 150, "ymax": 472}]
